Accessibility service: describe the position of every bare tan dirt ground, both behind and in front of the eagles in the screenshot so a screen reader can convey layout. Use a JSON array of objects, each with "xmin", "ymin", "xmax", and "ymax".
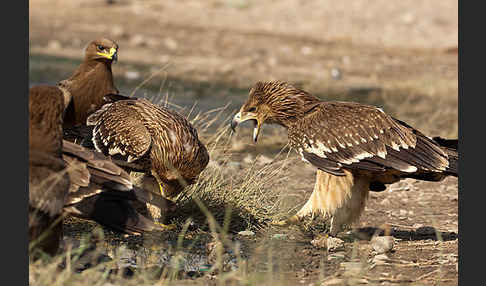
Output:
[{"xmin": 29, "ymin": 0, "xmax": 458, "ymax": 285}]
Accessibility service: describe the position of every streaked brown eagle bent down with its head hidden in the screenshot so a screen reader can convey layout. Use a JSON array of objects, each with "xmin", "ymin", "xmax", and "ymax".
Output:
[{"xmin": 86, "ymin": 98, "xmax": 209, "ymax": 225}]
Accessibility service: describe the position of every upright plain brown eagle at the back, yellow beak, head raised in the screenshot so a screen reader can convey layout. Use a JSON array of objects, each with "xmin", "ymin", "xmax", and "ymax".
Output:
[{"xmin": 58, "ymin": 38, "xmax": 118, "ymax": 128}]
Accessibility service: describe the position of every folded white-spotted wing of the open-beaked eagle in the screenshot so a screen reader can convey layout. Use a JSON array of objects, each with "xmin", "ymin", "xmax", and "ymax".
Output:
[{"xmin": 289, "ymin": 102, "xmax": 448, "ymax": 175}]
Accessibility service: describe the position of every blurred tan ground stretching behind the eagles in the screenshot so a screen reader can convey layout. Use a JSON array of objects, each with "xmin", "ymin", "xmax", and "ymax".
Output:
[{"xmin": 29, "ymin": 0, "xmax": 458, "ymax": 137}]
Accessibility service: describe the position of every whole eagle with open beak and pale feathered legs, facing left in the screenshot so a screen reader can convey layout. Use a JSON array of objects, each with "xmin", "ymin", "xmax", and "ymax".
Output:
[{"xmin": 231, "ymin": 81, "xmax": 458, "ymax": 236}]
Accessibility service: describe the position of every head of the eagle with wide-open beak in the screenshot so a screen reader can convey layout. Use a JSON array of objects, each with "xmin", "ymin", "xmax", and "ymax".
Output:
[{"xmin": 231, "ymin": 81, "xmax": 319, "ymax": 142}]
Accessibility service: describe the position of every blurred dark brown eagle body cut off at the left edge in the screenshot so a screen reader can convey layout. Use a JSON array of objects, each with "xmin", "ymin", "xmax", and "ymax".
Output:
[{"xmin": 28, "ymin": 86, "xmax": 70, "ymax": 255}]
